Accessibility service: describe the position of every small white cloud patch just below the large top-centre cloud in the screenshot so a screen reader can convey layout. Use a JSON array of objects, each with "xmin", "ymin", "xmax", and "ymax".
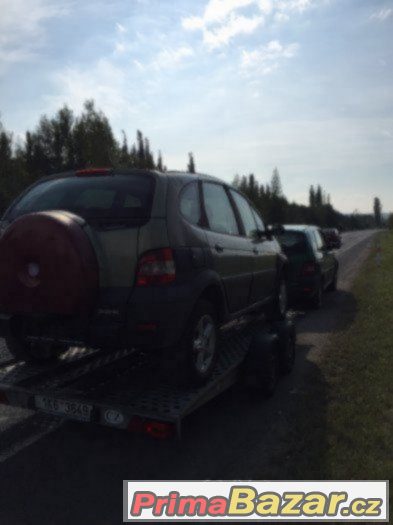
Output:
[{"xmin": 241, "ymin": 40, "xmax": 299, "ymax": 75}]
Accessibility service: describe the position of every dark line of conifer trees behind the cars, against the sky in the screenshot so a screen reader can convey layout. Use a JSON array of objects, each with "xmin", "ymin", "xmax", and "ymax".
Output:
[{"xmin": 0, "ymin": 100, "xmax": 382, "ymax": 229}]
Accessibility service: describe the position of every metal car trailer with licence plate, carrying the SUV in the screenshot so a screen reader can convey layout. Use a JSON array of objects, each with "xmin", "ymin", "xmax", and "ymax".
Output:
[{"xmin": 0, "ymin": 316, "xmax": 296, "ymax": 438}]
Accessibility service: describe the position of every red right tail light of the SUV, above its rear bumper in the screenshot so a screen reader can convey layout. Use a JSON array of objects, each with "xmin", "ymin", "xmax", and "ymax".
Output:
[{"xmin": 136, "ymin": 248, "xmax": 176, "ymax": 286}]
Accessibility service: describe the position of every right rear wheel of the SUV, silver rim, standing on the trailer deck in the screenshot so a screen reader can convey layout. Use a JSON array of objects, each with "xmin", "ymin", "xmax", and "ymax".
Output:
[{"xmin": 162, "ymin": 299, "xmax": 218, "ymax": 385}]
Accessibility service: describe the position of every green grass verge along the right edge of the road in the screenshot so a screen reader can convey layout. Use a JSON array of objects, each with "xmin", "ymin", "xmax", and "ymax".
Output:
[{"xmin": 287, "ymin": 232, "xmax": 393, "ymax": 490}]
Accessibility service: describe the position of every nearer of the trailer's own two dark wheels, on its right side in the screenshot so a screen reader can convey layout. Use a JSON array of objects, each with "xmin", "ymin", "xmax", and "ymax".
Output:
[{"xmin": 244, "ymin": 331, "xmax": 279, "ymax": 397}]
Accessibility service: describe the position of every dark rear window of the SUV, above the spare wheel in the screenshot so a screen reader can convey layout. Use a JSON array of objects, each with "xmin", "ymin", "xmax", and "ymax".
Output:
[{"xmin": 6, "ymin": 174, "xmax": 154, "ymax": 220}]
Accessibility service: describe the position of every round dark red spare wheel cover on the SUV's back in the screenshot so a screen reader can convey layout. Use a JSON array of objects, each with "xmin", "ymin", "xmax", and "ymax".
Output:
[{"xmin": 0, "ymin": 212, "xmax": 99, "ymax": 315}]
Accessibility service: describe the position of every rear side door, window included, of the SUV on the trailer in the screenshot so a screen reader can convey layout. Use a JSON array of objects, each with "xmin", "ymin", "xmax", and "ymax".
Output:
[{"xmin": 202, "ymin": 182, "xmax": 254, "ymax": 313}]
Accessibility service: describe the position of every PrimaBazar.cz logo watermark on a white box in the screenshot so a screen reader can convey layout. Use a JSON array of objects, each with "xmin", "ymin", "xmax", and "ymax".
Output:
[{"xmin": 123, "ymin": 481, "xmax": 389, "ymax": 523}]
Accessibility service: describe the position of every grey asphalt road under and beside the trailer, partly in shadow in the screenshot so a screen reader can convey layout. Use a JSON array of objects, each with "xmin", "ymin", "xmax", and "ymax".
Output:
[{"xmin": 0, "ymin": 231, "xmax": 375, "ymax": 525}]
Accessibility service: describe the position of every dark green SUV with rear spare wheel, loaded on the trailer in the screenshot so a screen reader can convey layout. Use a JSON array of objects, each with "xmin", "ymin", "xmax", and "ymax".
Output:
[{"xmin": 0, "ymin": 169, "xmax": 287, "ymax": 382}]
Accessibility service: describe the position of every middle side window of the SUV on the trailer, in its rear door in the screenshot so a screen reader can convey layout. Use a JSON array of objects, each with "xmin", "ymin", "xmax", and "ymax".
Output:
[{"xmin": 203, "ymin": 182, "xmax": 239, "ymax": 235}]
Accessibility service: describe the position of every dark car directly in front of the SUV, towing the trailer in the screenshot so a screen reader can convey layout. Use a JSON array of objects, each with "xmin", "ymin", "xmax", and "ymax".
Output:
[{"xmin": 277, "ymin": 225, "xmax": 338, "ymax": 308}]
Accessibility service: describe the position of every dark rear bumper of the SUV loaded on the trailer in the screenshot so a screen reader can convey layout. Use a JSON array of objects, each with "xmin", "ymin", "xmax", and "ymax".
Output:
[{"xmin": 0, "ymin": 278, "xmax": 208, "ymax": 349}]
